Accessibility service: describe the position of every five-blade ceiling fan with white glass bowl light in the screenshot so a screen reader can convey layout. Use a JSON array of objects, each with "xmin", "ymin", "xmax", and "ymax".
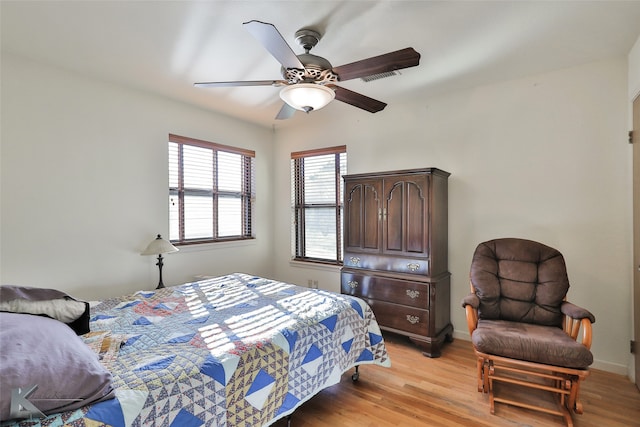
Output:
[{"xmin": 195, "ymin": 20, "xmax": 420, "ymax": 120}]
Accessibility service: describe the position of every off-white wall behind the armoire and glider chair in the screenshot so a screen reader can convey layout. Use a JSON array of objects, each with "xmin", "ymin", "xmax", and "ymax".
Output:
[{"xmin": 274, "ymin": 58, "xmax": 631, "ymax": 374}]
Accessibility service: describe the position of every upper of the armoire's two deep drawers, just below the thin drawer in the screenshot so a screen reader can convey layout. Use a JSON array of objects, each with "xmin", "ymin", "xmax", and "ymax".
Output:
[{"xmin": 341, "ymin": 272, "xmax": 429, "ymax": 309}]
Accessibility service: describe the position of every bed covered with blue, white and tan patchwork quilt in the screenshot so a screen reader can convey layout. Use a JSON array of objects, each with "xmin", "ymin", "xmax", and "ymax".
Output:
[{"xmin": 1, "ymin": 273, "xmax": 390, "ymax": 427}]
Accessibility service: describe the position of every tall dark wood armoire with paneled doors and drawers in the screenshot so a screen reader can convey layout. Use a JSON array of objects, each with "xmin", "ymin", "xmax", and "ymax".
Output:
[{"xmin": 341, "ymin": 168, "xmax": 453, "ymax": 357}]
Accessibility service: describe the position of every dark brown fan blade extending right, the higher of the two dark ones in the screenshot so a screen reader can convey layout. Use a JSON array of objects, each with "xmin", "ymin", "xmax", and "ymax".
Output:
[{"xmin": 333, "ymin": 47, "xmax": 420, "ymax": 81}]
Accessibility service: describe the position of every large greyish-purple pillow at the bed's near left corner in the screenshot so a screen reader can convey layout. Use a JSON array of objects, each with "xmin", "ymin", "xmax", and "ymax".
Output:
[{"xmin": 0, "ymin": 312, "xmax": 115, "ymax": 421}]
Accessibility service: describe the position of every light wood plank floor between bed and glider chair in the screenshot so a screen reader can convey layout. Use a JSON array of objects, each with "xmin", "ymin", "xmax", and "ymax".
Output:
[{"xmin": 274, "ymin": 333, "xmax": 640, "ymax": 427}]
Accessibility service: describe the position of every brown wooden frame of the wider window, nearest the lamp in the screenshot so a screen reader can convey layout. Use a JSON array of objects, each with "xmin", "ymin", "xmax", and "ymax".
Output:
[{"xmin": 167, "ymin": 134, "xmax": 256, "ymax": 246}]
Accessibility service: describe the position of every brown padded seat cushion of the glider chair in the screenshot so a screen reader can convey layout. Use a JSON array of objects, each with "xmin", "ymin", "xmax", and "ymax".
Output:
[{"xmin": 471, "ymin": 319, "xmax": 593, "ymax": 369}]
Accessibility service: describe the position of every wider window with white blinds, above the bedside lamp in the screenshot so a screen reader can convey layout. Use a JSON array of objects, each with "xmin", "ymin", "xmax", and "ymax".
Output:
[{"xmin": 169, "ymin": 134, "xmax": 255, "ymax": 244}]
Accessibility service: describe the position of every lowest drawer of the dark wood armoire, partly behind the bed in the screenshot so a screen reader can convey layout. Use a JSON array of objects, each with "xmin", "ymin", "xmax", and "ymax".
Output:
[{"xmin": 367, "ymin": 299, "xmax": 429, "ymax": 336}]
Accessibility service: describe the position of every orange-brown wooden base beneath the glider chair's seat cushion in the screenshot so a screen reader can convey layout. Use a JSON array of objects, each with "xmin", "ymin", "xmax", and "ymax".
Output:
[{"xmin": 476, "ymin": 351, "xmax": 589, "ymax": 427}]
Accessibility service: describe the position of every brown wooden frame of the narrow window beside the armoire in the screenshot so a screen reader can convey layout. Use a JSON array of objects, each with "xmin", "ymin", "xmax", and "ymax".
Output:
[{"xmin": 291, "ymin": 145, "xmax": 347, "ymax": 266}]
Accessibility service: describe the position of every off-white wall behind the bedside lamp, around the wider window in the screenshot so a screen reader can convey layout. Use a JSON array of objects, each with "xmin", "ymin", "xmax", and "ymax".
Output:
[{"xmin": 0, "ymin": 53, "xmax": 273, "ymax": 298}]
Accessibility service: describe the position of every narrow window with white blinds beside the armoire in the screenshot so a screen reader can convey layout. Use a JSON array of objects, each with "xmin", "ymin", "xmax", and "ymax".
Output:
[{"xmin": 291, "ymin": 145, "xmax": 347, "ymax": 264}]
